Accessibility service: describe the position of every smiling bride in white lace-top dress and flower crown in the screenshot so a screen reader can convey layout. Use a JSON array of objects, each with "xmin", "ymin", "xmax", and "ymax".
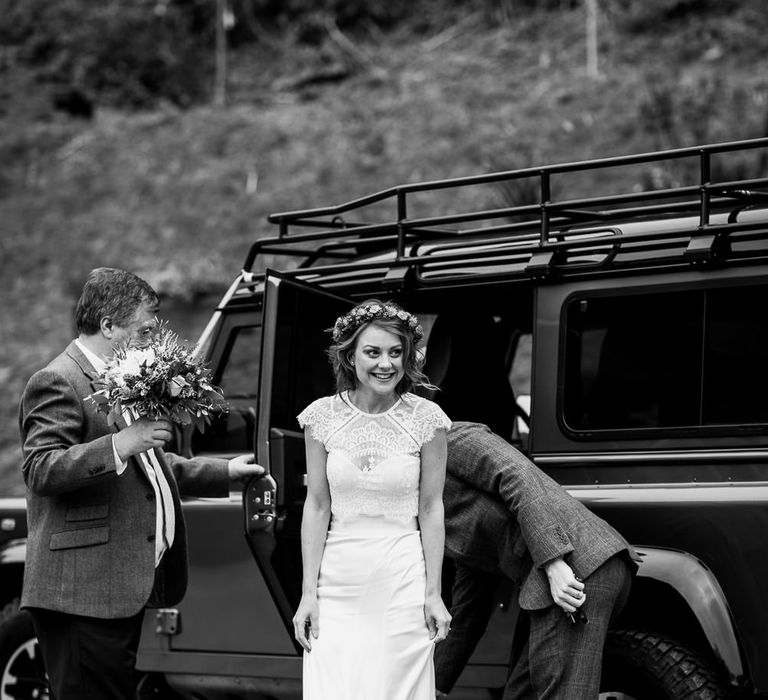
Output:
[{"xmin": 293, "ymin": 299, "xmax": 451, "ymax": 700}]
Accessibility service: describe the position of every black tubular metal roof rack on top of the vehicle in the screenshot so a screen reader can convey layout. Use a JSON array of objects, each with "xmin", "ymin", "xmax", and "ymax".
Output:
[{"xmin": 243, "ymin": 138, "xmax": 768, "ymax": 283}]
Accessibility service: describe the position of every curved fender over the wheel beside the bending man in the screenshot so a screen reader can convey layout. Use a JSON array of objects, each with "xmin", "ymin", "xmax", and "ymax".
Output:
[{"xmin": 636, "ymin": 547, "xmax": 744, "ymax": 680}]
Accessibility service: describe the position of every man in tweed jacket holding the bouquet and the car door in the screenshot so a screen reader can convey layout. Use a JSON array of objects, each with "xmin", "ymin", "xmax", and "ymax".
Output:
[{"xmin": 20, "ymin": 268, "xmax": 263, "ymax": 700}]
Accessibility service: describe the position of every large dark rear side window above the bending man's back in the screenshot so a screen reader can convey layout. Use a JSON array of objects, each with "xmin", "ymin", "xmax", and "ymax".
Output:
[{"xmin": 563, "ymin": 285, "xmax": 768, "ymax": 432}]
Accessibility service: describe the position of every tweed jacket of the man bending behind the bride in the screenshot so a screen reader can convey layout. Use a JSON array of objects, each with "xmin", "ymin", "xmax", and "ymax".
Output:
[{"xmin": 444, "ymin": 422, "xmax": 635, "ymax": 610}]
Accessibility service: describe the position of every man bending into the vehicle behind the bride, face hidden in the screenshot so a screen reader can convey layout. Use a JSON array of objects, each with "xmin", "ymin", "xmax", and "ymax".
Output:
[{"xmin": 435, "ymin": 422, "xmax": 636, "ymax": 700}]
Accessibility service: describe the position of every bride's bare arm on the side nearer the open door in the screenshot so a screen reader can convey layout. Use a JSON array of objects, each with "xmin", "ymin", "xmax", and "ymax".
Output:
[{"xmin": 293, "ymin": 429, "xmax": 331, "ymax": 651}]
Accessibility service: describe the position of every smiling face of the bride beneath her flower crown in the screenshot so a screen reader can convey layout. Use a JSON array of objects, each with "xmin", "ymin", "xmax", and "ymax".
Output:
[{"xmin": 354, "ymin": 324, "xmax": 405, "ymax": 395}]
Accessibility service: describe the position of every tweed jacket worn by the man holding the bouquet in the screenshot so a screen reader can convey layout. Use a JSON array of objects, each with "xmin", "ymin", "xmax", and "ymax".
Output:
[{"xmin": 19, "ymin": 342, "xmax": 228, "ymax": 618}]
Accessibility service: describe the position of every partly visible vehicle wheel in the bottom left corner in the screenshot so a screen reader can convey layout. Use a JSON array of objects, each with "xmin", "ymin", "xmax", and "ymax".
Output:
[{"xmin": 0, "ymin": 598, "xmax": 50, "ymax": 700}]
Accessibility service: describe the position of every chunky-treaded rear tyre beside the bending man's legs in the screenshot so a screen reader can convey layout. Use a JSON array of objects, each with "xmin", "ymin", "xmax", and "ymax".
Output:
[{"xmin": 600, "ymin": 630, "xmax": 732, "ymax": 700}]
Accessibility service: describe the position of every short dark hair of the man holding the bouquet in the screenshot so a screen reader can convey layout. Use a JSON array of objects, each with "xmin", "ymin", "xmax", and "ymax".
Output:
[{"xmin": 75, "ymin": 267, "xmax": 159, "ymax": 335}]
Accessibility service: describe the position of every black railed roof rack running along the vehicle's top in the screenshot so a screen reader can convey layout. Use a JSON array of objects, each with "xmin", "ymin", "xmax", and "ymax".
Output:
[{"xmin": 243, "ymin": 138, "xmax": 768, "ymax": 282}]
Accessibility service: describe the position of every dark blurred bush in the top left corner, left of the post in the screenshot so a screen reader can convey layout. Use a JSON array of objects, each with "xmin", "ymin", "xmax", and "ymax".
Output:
[{"xmin": 0, "ymin": 0, "xmax": 214, "ymax": 107}]
